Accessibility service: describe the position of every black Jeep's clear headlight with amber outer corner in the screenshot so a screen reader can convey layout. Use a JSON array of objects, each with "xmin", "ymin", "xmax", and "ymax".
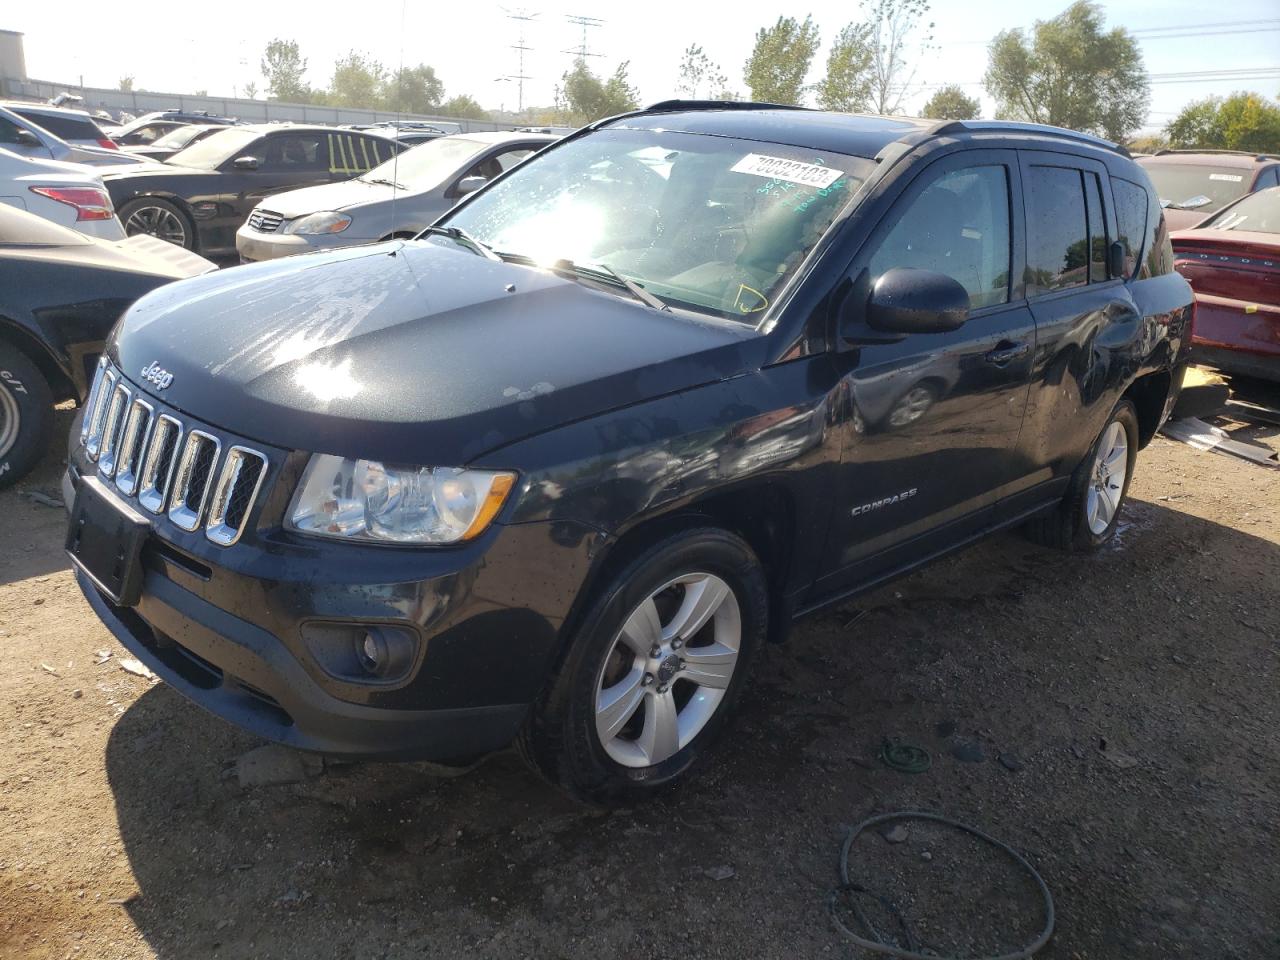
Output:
[{"xmin": 288, "ymin": 453, "xmax": 516, "ymax": 544}]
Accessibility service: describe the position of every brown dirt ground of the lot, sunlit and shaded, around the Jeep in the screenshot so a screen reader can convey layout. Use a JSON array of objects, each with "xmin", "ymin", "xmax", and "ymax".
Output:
[{"xmin": 0, "ymin": 399, "xmax": 1280, "ymax": 960}]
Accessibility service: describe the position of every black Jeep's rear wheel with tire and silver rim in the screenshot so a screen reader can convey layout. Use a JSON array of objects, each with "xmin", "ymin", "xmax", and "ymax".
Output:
[{"xmin": 1023, "ymin": 398, "xmax": 1138, "ymax": 550}]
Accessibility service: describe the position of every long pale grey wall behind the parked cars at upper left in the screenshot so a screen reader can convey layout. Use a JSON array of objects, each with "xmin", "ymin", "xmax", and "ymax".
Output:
[{"xmin": 0, "ymin": 77, "xmax": 511, "ymax": 133}]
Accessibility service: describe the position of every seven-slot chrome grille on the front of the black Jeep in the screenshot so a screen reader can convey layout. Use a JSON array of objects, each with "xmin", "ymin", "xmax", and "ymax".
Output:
[{"xmin": 81, "ymin": 357, "xmax": 270, "ymax": 547}]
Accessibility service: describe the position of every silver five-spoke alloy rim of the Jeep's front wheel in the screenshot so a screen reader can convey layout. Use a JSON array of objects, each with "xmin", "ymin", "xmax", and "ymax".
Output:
[{"xmin": 595, "ymin": 572, "xmax": 742, "ymax": 767}]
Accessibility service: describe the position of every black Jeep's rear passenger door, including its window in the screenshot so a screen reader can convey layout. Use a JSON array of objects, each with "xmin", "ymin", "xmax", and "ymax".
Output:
[{"xmin": 998, "ymin": 151, "xmax": 1142, "ymax": 518}]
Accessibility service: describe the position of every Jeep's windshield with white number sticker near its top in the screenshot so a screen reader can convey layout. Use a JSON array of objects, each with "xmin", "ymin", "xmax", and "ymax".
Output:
[{"xmin": 445, "ymin": 129, "xmax": 874, "ymax": 324}]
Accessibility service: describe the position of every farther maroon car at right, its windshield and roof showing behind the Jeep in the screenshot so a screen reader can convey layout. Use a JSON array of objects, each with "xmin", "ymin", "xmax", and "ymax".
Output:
[{"xmin": 1138, "ymin": 150, "xmax": 1280, "ymax": 230}]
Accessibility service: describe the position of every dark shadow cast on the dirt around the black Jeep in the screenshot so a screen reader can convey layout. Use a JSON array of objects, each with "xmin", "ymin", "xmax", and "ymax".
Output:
[{"xmin": 106, "ymin": 500, "xmax": 1280, "ymax": 960}]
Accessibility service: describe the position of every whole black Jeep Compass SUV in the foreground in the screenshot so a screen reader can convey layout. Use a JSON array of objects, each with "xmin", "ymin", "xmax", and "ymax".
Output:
[{"xmin": 67, "ymin": 102, "xmax": 1192, "ymax": 800}]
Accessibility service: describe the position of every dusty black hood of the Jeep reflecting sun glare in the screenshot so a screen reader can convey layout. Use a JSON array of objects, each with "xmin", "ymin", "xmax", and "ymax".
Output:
[{"xmin": 109, "ymin": 241, "xmax": 764, "ymax": 466}]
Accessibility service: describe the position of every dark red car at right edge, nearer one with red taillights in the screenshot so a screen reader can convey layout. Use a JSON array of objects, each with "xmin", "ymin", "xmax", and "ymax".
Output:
[{"xmin": 1170, "ymin": 187, "xmax": 1280, "ymax": 381}]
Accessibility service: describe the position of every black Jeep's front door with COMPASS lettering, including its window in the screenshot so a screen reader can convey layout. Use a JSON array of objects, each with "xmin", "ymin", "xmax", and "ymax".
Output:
[{"xmin": 818, "ymin": 150, "xmax": 1036, "ymax": 594}]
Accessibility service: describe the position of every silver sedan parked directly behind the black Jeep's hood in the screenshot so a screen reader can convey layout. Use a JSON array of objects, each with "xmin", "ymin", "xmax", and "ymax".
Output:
[{"xmin": 236, "ymin": 133, "xmax": 557, "ymax": 260}]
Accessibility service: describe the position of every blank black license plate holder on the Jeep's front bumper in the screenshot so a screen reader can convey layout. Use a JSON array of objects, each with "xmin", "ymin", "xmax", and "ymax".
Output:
[{"xmin": 67, "ymin": 476, "xmax": 151, "ymax": 607}]
